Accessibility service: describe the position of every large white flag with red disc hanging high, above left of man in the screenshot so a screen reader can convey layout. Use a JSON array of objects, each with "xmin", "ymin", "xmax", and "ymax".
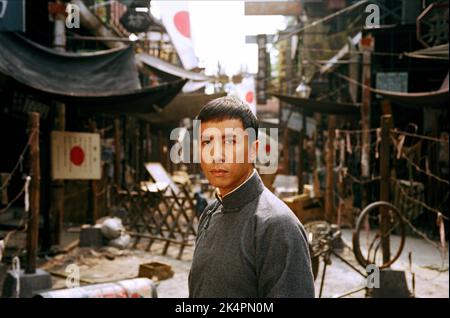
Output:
[{"xmin": 152, "ymin": 1, "xmax": 198, "ymax": 70}]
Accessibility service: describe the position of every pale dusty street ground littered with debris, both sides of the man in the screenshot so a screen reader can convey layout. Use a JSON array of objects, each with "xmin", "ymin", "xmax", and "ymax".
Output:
[{"xmin": 30, "ymin": 230, "xmax": 449, "ymax": 298}]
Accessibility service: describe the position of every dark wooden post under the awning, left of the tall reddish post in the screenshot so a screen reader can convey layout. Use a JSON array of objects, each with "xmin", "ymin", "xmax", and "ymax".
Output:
[{"xmin": 325, "ymin": 115, "xmax": 336, "ymax": 222}]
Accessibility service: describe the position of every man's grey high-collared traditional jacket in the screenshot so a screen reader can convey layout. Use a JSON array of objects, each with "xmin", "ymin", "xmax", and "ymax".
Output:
[{"xmin": 189, "ymin": 173, "xmax": 314, "ymax": 298}]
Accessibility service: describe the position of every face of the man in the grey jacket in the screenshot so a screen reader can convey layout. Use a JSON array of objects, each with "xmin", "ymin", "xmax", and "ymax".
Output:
[{"xmin": 199, "ymin": 119, "xmax": 258, "ymax": 196}]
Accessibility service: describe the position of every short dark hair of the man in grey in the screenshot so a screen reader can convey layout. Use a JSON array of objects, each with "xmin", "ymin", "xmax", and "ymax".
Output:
[{"xmin": 197, "ymin": 96, "xmax": 258, "ymax": 138}]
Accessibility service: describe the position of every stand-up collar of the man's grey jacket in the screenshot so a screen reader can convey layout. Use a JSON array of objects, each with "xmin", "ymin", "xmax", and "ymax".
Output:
[{"xmin": 216, "ymin": 170, "xmax": 264, "ymax": 212}]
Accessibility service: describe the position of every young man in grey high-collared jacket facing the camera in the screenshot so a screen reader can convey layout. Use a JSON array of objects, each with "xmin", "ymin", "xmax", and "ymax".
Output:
[{"xmin": 189, "ymin": 97, "xmax": 314, "ymax": 298}]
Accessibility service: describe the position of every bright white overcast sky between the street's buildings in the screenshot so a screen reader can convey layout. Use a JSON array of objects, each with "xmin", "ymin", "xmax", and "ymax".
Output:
[{"xmin": 152, "ymin": 0, "xmax": 286, "ymax": 75}]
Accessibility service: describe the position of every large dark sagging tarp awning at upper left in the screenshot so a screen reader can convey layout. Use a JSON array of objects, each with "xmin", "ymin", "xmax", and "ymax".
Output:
[{"xmin": 0, "ymin": 32, "xmax": 186, "ymax": 113}]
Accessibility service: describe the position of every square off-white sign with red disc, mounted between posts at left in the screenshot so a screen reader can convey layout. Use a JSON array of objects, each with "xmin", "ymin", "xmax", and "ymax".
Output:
[{"xmin": 51, "ymin": 131, "xmax": 101, "ymax": 180}]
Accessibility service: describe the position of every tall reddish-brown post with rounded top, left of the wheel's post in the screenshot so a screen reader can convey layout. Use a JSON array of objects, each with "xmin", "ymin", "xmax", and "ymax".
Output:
[{"xmin": 361, "ymin": 34, "xmax": 375, "ymax": 208}]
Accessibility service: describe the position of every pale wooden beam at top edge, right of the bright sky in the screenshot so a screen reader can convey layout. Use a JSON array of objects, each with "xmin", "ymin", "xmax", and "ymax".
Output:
[{"xmin": 245, "ymin": 1, "xmax": 301, "ymax": 16}]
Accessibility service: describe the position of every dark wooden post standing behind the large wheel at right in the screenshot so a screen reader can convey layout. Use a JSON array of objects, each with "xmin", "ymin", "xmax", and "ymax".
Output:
[{"xmin": 380, "ymin": 115, "xmax": 392, "ymax": 263}]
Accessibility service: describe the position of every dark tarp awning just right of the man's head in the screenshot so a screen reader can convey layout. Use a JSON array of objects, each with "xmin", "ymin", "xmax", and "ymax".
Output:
[{"xmin": 272, "ymin": 94, "xmax": 360, "ymax": 115}]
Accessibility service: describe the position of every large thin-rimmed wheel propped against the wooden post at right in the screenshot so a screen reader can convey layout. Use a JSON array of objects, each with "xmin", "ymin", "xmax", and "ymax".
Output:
[{"xmin": 353, "ymin": 201, "xmax": 405, "ymax": 269}]
